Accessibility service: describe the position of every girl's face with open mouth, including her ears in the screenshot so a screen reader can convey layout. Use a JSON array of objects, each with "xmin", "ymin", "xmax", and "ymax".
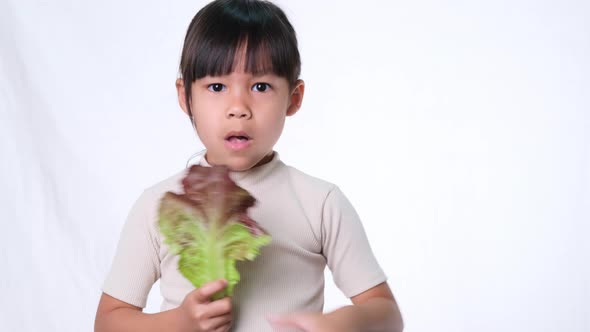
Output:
[{"xmin": 176, "ymin": 61, "xmax": 304, "ymax": 171}]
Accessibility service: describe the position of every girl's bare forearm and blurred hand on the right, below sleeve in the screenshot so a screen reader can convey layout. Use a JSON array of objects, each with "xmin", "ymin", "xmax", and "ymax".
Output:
[{"xmin": 269, "ymin": 283, "xmax": 403, "ymax": 332}]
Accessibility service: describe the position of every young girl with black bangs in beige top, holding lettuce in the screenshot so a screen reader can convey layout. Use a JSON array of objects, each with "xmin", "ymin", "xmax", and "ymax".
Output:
[{"xmin": 95, "ymin": 0, "xmax": 402, "ymax": 332}]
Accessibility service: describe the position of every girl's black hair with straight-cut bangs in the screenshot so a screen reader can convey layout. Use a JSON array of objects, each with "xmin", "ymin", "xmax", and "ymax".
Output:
[{"xmin": 180, "ymin": 0, "xmax": 301, "ymax": 120}]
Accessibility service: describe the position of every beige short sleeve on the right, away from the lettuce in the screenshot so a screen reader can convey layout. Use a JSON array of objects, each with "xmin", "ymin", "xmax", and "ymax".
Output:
[{"xmin": 321, "ymin": 187, "xmax": 387, "ymax": 298}]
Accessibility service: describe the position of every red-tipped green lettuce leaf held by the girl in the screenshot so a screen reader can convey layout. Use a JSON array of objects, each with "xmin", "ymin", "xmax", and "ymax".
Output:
[{"xmin": 159, "ymin": 165, "xmax": 271, "ymax": 299}]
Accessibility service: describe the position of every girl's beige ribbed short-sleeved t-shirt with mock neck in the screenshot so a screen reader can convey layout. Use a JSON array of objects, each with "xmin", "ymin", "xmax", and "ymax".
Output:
[{"xmin": 102, "ymin": 153, "xmax": 386, "ymax": 332}]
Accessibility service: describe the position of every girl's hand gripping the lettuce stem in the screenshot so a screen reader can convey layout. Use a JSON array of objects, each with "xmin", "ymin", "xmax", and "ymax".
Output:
[{"xmin": 177, "ymin": 280, "xmax": 232, "ymax": 332}]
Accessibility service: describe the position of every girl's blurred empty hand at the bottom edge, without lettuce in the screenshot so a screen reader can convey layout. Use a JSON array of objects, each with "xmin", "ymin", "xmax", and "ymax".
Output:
[{"xmin": 267, "ymin": 313, "xmax": 352, "ymax": 332}]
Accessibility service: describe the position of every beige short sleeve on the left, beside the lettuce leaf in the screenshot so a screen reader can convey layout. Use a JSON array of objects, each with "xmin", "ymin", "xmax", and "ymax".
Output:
[{"xmin": 102, "ymin": 191, "xmax": 160, "ymax": 308}]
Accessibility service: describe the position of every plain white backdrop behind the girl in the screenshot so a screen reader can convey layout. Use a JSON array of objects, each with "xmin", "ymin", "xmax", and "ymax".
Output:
[{"xmin": 0, "ymin": 0, "xmax": 590, "ymax": 332}]
